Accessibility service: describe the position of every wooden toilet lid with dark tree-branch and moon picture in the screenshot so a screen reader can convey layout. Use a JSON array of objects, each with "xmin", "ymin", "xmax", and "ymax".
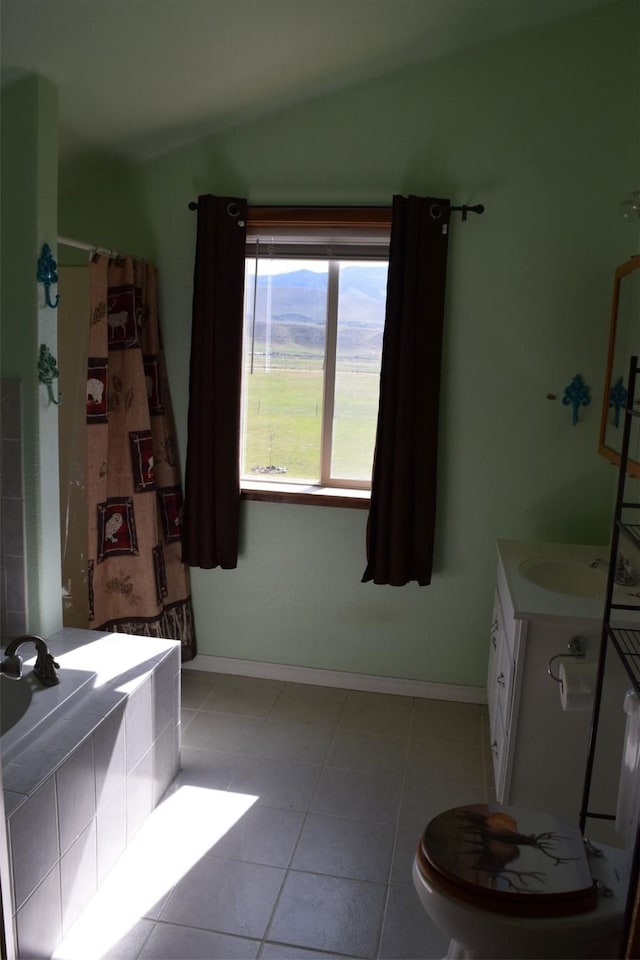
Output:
[{"xmin": 416, "ymin": 803, "xmax": 597, "ymax": 916}]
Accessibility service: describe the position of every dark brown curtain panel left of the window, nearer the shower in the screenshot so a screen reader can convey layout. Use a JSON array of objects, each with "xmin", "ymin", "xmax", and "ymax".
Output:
[{"xmin": 182, "ymin": 194, "xmax": 247, "ymax": 569}]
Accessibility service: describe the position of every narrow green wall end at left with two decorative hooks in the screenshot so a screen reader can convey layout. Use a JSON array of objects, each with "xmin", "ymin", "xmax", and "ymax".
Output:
[{"xmin": 0, "ymin": 77, "xmax": 62, "ymax": 635}]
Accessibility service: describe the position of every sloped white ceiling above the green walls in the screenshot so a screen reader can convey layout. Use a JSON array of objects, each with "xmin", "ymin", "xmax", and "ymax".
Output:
[{"xmin": 0, "ymin": 0, "xmax": 608, "ymax": 182}]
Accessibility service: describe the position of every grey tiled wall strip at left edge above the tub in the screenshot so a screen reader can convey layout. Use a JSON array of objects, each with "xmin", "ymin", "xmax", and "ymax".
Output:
[{"xmin": 0, "ymin": 377, "xmax": 27, "ymax": 641}]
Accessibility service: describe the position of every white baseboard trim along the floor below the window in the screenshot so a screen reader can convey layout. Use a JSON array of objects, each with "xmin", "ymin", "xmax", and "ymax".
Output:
[{"xmin": 182, "ymin": 654, "xmax": 487, "ymax": 703}]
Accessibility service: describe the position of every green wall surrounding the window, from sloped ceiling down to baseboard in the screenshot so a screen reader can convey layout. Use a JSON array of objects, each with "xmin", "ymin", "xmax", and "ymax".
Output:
[{"xmin": 60, "ymin": 2, "xmax": 640, "ymax": 686}]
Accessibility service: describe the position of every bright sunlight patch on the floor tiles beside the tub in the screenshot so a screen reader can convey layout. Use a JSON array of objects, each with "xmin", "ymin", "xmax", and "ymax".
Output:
[{"xmin": 52, "ymin": 785, "xmax": 258, "ymax": 960}]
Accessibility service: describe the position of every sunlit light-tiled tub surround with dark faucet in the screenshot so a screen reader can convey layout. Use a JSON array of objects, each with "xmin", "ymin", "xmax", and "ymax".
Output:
[{"xmin": 2, "ymin": 629, "xmax": 180, "ymax": 960}]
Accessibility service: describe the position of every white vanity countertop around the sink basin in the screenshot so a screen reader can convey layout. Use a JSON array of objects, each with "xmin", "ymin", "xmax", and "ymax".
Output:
[{"xmin": 496, "ymin": 540, "xmax": 640, "ymax": 627}]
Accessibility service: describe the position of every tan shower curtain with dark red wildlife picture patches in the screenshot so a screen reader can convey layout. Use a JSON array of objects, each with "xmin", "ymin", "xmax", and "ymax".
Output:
[{"xmin": 87, "ymin": 254, "xmax": 196, "ymax": 660}]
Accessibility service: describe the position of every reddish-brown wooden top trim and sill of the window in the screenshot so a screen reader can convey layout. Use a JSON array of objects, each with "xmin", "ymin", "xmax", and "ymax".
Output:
[{"xmin": 240, "ymin": 206, "xmax": 391, "ymax": 510}]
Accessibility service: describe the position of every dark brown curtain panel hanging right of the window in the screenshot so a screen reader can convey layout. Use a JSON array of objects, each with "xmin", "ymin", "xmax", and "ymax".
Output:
[{"xmin": 362, "ymin": 196, "xmax": 450, "ymax": 586}]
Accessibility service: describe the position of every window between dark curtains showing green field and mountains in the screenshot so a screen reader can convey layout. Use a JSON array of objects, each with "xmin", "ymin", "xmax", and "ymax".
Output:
[{"xmin": 240, "ymin": 208, "xmax": 390, "ymax": 506}]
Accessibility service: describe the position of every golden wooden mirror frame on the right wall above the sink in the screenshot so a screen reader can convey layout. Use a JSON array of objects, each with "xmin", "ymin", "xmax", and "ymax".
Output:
[{"xmin": 598, "ymin": 255, "xmax": 640, "ymax": 478}]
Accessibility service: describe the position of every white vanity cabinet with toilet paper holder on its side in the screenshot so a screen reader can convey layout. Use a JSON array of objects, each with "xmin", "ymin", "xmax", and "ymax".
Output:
[{"xmin": 487, "ymin": 541, "xmax": 627, "ymax": 818}]
